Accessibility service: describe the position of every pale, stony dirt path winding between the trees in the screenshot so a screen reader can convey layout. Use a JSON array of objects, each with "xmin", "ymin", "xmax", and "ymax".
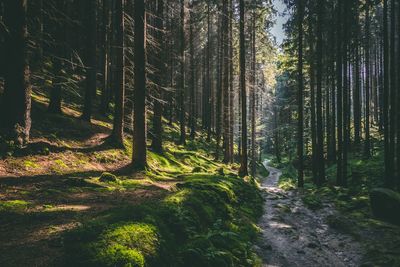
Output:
[{"xmin": 257, "ymin": 162, "xmax": 361, "ymax": 267}]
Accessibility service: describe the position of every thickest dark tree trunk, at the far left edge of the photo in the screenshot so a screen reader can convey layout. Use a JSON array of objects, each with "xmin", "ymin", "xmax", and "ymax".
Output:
[{"xmin": 1, "ymin": 0, "xmax": 31, "ymax": 146}]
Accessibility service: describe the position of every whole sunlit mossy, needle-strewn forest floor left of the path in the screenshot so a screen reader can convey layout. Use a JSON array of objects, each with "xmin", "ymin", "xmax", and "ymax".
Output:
[{"xmin": 0, "ymin": 93, "xmax": 263, "ymax": 266}]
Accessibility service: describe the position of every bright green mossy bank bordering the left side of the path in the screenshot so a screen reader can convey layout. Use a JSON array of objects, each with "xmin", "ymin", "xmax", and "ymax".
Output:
[{"xmin": 66, "ymin": 174, "xmax": 262, "ymax": 267}]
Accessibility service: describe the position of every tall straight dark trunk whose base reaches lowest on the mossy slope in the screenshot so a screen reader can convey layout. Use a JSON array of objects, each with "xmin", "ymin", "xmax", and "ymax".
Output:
[{"xmin": 132, "ymin": 0, "xmax": 147, "ymax": 169}]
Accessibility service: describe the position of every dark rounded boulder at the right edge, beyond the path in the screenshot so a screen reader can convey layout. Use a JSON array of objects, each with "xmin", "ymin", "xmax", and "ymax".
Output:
[{"xmin": 370, "ymin": 188, "xmax": 400, "ymax": 225}]
